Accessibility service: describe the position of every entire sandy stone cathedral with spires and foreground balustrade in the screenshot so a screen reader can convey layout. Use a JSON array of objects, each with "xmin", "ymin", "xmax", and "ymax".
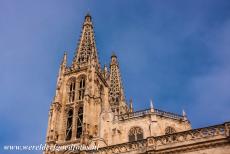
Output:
[{"xmin": 44, "ymin": 14, "xmax": 230, "ymax": 154}]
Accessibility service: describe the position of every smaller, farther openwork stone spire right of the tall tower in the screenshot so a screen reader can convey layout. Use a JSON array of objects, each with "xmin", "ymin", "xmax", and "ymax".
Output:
[{"xmin": 109, "ymin": 54, "xmax": 126, "ymax": 112}]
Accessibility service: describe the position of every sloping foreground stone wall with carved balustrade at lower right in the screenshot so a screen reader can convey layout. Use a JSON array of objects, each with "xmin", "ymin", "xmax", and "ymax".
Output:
[{"xmin": 91, "ymin": 122, "xmax": 230, "ymax": 154}]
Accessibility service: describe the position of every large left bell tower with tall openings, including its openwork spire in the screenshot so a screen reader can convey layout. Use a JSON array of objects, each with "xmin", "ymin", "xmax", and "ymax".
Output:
[{"xmin": 45, "ymin": 14, "xmax": 109, "ymax": 154}]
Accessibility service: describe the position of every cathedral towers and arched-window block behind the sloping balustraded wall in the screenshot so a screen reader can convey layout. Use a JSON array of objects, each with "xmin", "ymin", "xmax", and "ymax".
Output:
[{"xmin": 45, "ymin": 14, "xmax": 191, "ymax": 154}]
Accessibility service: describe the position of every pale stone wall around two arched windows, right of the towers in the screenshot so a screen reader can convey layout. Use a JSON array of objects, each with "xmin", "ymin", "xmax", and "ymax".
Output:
[{"xmin": 100, "ymin": 109, "xmax": 191, "ymax": 145}]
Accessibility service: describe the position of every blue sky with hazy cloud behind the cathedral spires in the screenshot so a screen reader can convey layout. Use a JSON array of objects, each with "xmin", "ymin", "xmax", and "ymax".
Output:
[{"xmin": 0, "ymin": 0, "xmax": 230, "ymax": 153}]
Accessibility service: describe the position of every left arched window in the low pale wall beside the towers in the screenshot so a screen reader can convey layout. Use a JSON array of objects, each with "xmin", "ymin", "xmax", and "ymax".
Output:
[{"xmin": 129, "ymin": 127, "xmax": 143, "ymax": 142}]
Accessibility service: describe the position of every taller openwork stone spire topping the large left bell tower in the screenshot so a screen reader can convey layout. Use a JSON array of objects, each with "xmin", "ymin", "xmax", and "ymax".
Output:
[{"xmin": 72, "ymin": 13, "xmax": 100, "ymax": 67}]
